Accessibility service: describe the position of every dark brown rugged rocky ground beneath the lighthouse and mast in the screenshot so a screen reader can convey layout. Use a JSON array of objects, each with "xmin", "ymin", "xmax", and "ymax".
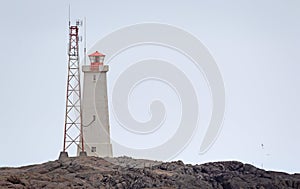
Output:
[{"xmin": 0, "ymin": 157, "xmax": 300, "ymax": 189}]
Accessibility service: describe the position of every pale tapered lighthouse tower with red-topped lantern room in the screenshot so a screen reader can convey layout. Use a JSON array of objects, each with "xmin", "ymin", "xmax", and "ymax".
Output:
[{"xmin": 82, "ymin": 51, "xmax": 112, "ymax": 157}]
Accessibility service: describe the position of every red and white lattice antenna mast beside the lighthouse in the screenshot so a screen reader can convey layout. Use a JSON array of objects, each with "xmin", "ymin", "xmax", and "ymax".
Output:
[{"xmin": 60, "ymin": 21, "xmax": 86, "ymax": 158}]
